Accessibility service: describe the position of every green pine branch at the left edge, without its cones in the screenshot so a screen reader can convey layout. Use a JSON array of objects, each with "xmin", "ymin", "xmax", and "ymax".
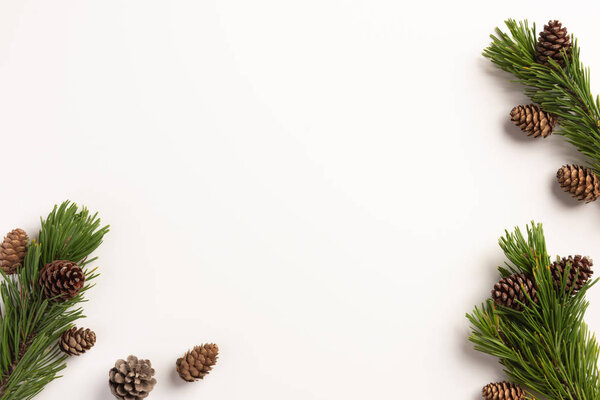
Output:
[{"xmin": 0, "ymin": 201, "xmax": 108, "ymax": 400}]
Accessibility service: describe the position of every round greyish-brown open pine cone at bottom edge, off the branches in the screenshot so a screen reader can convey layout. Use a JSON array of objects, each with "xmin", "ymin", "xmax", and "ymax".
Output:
[{"xmin": 108, "ymin": 356, "xmax": 156, "ymax": 400}]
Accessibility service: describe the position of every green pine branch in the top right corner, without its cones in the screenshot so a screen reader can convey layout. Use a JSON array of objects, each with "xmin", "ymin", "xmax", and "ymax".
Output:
[{"xmin": 483, "ymin": 19, "xmax": 600, "ymax": 175}]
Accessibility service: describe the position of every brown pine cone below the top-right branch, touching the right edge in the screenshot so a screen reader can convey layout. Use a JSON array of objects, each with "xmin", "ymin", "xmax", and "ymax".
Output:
[{"xmin": 556, "ymin": 165, "xmax": 600, "ymax": 203}]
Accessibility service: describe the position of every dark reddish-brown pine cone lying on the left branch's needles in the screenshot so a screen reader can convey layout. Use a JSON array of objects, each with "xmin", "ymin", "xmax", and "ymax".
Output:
[{"xmin": 39, "ymin": 260, "xmax": 85, "ymax": 301}]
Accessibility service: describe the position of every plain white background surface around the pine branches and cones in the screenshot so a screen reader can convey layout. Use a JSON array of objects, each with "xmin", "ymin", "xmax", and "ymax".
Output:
[{"xmin": 0, "ymin": 0, "xmax": 600, "ymax": 400}]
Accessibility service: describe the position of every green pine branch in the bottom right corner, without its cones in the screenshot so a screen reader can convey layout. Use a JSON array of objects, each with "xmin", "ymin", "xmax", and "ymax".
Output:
[{"xmin": 467, "ymin": 223, "xmax": 600, "ymax": 400}]
